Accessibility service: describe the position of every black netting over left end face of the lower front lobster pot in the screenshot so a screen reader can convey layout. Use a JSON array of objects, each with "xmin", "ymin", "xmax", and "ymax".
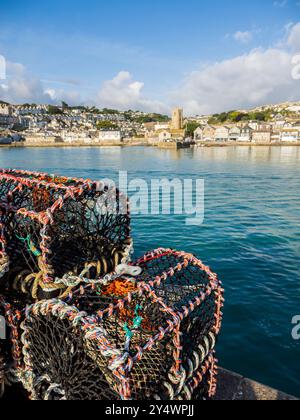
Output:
[{"xmin": 25, "ymin": 314, "xmax": 118, "ymax": 400}]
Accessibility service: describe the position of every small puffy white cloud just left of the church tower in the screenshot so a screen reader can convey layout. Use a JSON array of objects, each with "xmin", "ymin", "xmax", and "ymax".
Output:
[{"xmin": 97, "ymin": 71, "xmax": 167, "ymax": 112}]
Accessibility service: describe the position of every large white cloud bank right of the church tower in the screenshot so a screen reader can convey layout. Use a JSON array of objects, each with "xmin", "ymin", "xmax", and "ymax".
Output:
[{"xmin": 172, "ymin": 24, "xmax": 300, "ymax": 114}]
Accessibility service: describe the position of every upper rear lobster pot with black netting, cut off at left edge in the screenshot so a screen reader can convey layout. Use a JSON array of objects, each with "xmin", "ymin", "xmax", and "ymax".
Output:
[{"xmin": 0, "ymin": 170, "xmax": 131, "ymax": 296}]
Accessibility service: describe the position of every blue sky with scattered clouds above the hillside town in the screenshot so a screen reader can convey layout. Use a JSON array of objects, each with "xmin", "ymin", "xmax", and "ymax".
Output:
[{"xmin": 0, "ymin": 0, "xmax": 300, "ymax": 113}]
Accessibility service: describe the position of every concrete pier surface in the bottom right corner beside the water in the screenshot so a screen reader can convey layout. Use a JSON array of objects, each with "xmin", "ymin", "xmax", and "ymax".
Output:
[{"xmin": 215, "ymin": 369, "xmax": 298, "ymax": 401}]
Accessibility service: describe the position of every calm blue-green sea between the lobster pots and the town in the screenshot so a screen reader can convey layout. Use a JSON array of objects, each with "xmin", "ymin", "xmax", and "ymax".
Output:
[{"xmin": 0, "ymin": 147, "xmax": 300, "ymax": 396}]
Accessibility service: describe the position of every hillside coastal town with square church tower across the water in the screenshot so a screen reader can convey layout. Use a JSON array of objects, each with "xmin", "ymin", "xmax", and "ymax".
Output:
[{"xmin": 0, "ymin": 101, "xmax": 300, "ymax": 148}]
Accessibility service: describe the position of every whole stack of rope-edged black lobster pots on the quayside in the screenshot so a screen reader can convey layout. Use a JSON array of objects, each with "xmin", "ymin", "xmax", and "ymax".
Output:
[{"xmin": 0, "ymin": 171, "xmax": 224, "ymax": 400}]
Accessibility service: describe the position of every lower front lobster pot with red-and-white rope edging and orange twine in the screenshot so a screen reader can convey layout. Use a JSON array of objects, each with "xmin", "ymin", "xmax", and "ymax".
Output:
[{"xmin": 22, "ymin": 249, "xmax": 223, "ymax": 400}]
